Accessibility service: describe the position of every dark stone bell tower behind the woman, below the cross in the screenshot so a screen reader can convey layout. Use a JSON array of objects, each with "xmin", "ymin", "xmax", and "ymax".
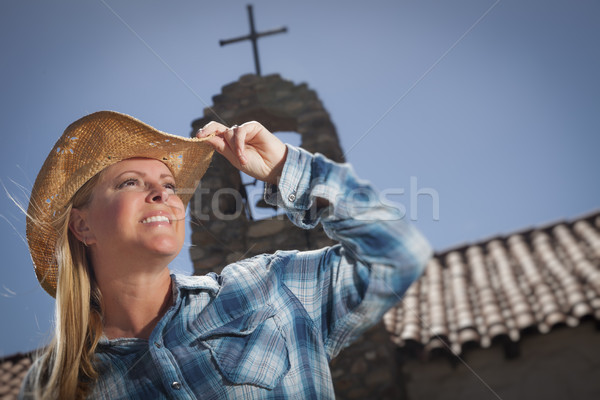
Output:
[{"xmin": 190, "ymin": 74, "xmax": 398, "ymax": 399}]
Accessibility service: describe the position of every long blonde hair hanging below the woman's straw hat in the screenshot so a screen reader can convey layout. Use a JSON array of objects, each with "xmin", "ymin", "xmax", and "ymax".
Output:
[{"xmin": 31, "ymin": 174, "xmax": 102, "ymax": 400}]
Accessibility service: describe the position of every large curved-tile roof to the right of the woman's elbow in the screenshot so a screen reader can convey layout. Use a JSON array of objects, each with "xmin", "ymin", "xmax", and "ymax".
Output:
[{"xmin": 384, "ymin": 211, "xmax": 600, "ymax": 357}]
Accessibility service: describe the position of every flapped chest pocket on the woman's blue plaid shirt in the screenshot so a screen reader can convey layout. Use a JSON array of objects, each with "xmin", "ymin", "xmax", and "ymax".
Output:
[{"xmin": 199, "ymin": 306, "xmax": 290, "ymax": 389}]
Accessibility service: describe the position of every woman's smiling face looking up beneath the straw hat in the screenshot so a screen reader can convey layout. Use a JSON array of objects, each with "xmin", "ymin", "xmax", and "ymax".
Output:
[{"xmin": 75, "ymin": 158, "xmax": 185, "ymax": 261}]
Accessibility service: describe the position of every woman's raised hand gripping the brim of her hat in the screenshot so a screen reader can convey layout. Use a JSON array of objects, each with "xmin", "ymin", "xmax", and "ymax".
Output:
[{"xmin": 196, "ymin": 121, "xmax": 287, "ymax": 184}]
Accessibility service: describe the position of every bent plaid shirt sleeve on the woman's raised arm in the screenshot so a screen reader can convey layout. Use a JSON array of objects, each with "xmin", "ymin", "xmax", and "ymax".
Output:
[{"xmin": 265, "ymin": 145, "xmax": 431, "ymax": 358}]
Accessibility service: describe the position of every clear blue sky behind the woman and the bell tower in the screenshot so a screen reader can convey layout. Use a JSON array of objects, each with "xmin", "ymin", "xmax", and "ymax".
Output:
[{"xmin": 0, "ymin": 0, "xmax": 600, "ymax": 356}]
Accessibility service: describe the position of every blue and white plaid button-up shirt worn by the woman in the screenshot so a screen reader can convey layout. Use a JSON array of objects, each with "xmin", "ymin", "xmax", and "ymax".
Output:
[{"xmin": 22, "ymin": 146, "xmax": 431, "ymax": 400}]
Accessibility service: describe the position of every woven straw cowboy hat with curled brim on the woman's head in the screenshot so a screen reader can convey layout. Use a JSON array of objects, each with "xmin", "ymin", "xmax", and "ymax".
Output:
[{"xmin": 26, "ymin": 111, "xmax": 213, "ymax": 297}]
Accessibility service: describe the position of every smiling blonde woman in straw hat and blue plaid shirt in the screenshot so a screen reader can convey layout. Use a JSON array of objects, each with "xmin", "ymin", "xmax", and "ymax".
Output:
[{"xmin": 21, "ymin": 111, "xmax": 430, "ymax": 399}]
